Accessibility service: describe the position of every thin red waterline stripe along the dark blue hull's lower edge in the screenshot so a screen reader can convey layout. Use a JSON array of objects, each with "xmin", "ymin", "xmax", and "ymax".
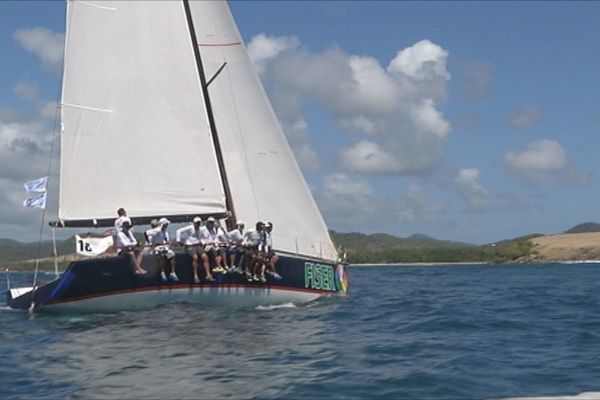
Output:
[{"xmin": 43, "ymin": 283, "xmax": 338, "ymax": 306}]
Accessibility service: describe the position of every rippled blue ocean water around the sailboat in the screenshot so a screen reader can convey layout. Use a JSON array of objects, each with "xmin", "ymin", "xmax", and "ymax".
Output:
[{"xmin": 0, "ymin": 264, "xmax": 600, "ymax": 399}]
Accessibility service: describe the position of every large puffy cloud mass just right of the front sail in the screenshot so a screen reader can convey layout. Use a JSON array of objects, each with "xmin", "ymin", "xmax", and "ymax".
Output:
[{"xmin": 248, "ymin": 35, "xmax": 451, "ymax": 174}]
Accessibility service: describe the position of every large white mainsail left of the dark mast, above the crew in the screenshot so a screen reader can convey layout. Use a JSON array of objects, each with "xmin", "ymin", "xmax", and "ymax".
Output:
[{"xmin": 58, "ymin": 0, "xmax": 226, "ymax": 221}]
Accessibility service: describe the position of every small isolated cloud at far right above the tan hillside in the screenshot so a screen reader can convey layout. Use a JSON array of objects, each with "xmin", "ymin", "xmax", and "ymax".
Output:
[{"xmin": 504, "ymin": 139, "xmax": 587, "ymax": 185}]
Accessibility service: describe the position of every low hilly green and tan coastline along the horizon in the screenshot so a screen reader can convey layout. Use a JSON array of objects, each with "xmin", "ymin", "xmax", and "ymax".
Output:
[{"xmin": 0, "ymin": 222, "xmax": 600, "ymax": 270}]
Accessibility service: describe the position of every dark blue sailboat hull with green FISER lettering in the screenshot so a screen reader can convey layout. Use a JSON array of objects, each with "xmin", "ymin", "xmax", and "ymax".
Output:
[{"xmin": 7, "ymin": 253, "xmax": 348, "ymax": 312}]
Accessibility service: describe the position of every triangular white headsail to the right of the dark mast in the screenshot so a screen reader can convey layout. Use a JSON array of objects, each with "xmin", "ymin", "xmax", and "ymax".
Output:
[{"xmin": 190, "ymin": 1, "xmax": 337, "ymax": 260}]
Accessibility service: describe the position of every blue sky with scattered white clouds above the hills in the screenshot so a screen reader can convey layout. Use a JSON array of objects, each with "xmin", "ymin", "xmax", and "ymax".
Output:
[{"xmin": 0, "ymin": 1, "xmax": 600, "ymax": 244}]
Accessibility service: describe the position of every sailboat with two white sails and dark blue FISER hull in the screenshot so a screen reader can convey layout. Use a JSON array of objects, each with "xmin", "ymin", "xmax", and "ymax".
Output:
[{"xmin": 7, "ymin": 0, "xmax": 348, "ymax": 312}]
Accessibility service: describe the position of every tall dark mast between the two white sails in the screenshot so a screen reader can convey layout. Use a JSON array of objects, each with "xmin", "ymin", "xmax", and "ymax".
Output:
[{"xmin": 183, "ymin": 0, "xmax": 236, "ymax": 230}]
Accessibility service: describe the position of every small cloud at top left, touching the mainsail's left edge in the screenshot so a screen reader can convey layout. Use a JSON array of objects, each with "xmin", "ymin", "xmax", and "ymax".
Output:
[{"xmin": 13, "ymin": 27, "xmax": 64, "ymax": 71}]
